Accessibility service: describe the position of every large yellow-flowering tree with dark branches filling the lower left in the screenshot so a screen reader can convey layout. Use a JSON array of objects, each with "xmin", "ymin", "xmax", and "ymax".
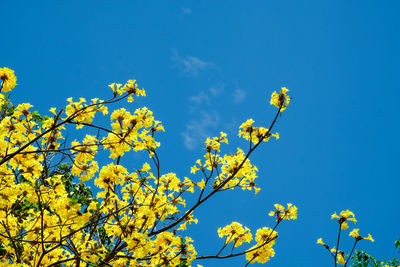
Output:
[{"xmin": 0, "ymin": 68, "xmax": 297, "ymax": 266}]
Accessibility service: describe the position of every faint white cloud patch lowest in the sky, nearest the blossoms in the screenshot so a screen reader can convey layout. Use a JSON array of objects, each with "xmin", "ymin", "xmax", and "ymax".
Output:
[{"xmin": 182, "ymin": 111, "xmax": 220, "ymax": 150}]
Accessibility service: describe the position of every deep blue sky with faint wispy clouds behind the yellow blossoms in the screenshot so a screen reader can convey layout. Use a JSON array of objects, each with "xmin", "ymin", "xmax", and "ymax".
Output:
[{"xmin": 0, "ymin": 0, "xmax": 400, "ymax": 267}]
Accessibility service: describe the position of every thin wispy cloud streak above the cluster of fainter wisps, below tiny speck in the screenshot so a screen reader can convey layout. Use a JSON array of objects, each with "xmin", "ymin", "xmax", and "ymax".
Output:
[{"xmin": 172, "ymin": 50, "xmax": 214, "ymax": 76}]
